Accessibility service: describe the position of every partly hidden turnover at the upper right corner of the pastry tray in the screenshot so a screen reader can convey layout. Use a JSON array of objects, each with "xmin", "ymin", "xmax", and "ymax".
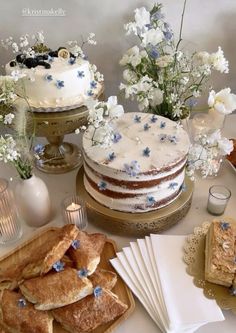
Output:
[{"xmin": 68, "ymin": 231, "xmax": 106, "ymax": 275}]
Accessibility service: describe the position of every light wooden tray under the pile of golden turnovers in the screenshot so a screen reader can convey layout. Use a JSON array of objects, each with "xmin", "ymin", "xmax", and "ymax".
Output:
[{"xmin": 0, "ymin": 227, "xmax": 135, "ymax": 333}]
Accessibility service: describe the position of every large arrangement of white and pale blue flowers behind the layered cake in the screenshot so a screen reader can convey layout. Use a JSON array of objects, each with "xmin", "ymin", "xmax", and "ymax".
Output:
[{"xmin": 120, "ymin": 0, "xmax": 236, "ymax": 120}]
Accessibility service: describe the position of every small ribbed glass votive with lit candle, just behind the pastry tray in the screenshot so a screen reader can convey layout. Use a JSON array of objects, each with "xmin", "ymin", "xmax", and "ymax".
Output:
[{"xmin": 62, "ymin": 195, "xmax": 88, "ymax": 230}]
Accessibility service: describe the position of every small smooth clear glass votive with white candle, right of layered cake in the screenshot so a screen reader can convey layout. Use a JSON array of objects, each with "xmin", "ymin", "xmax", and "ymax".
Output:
[{"xmin": 207, "ymin": 185, "xmax": 231, "ymax": 215}]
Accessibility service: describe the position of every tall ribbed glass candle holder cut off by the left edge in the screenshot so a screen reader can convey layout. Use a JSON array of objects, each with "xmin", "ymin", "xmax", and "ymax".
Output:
[{"xmin": 0, "ymin": 178, "xmax": 22, "ymax": 244}]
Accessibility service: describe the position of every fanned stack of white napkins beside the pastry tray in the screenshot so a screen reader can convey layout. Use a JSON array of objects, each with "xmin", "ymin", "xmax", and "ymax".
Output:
[{"xmin": 111, "ymin": 235, "xmax": 224, "ymax": 333}]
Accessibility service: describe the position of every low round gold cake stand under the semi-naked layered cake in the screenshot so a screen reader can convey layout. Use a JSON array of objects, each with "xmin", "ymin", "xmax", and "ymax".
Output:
[{"xmin": 76, "ymin": 168, "xmax": 194, "ymax": 237}]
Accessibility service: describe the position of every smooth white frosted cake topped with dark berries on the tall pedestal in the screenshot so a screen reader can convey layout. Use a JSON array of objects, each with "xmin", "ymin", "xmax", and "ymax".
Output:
[{"xmin": 6, "ymin": 51, "xmax": 102, "ymax": 111}]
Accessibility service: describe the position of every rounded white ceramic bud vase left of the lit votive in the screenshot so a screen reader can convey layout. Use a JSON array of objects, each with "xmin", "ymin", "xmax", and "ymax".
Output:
[{"xmin": 15, "ymin": 175, "xmax": 51, "ymax": 227}]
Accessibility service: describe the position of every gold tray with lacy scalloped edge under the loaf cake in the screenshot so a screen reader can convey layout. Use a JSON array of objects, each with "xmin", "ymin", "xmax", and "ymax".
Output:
[{"xmin": 183, "ymin": 221, "xmax": 236, "ymax": 314}]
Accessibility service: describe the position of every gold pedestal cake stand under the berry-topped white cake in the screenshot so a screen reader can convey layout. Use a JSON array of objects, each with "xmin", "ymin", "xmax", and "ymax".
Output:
[{"xmin": 33, "ymin": 87, "xmax": 104, "ymax": 174}]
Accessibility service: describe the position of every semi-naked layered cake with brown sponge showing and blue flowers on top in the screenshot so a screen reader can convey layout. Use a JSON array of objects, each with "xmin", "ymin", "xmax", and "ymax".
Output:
[{"xmin": 83, "ymin": 112, "xmax": 190, "ymax": 213}]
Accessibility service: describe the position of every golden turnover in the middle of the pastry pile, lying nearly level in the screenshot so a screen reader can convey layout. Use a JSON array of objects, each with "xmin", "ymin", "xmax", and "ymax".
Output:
[{"xmin": 20, "ymin": 268, "xmax": 93, "ymax": 310}]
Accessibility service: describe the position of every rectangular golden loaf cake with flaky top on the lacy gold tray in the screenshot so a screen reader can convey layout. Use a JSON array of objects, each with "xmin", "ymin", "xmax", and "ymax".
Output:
[{"xmin": 205, "ymin": 218, "xmax": 236, "ymax": 287}]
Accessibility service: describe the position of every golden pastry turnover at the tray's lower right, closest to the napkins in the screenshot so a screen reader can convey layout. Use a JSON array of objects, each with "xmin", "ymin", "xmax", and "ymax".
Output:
[{"xmin": 52, "ymin": 289, "xmax": 127, "ymax": 333}]
